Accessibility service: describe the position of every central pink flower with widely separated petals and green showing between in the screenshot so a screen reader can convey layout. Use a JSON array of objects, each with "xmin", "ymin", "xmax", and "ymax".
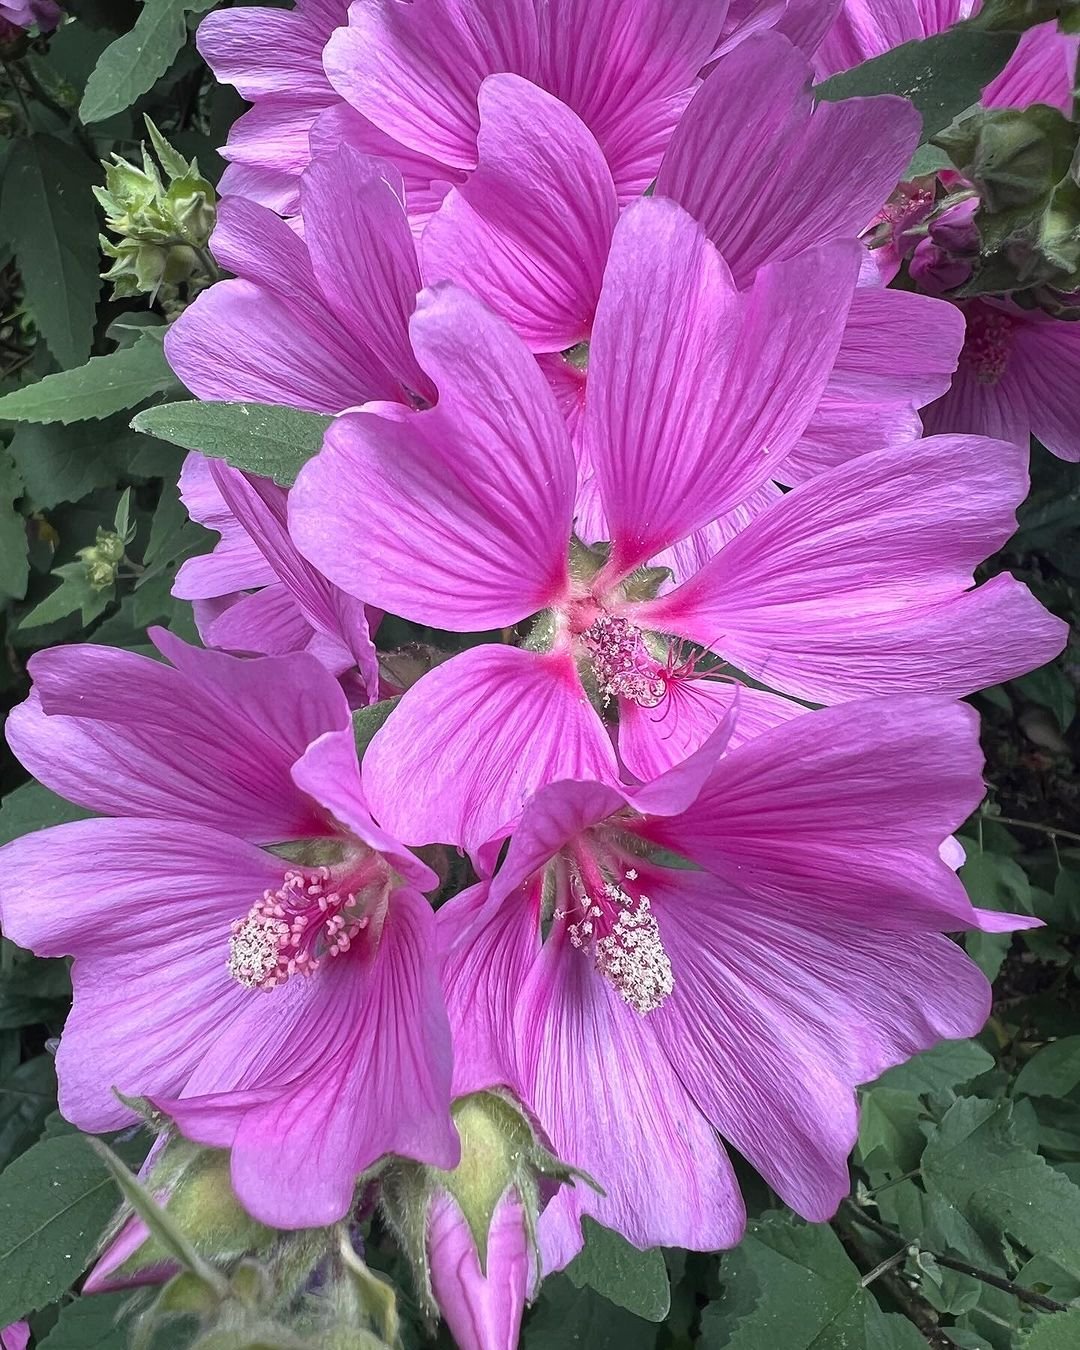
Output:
[{"xmin": 290, "ymin": 200, "xmax": 1064, "ymax": 849}]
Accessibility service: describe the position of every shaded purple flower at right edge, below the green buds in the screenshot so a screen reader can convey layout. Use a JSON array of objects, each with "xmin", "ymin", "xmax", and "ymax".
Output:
[{"xmin": 922, "ymin": 298, "xmax": 1080, "ymax": 463}]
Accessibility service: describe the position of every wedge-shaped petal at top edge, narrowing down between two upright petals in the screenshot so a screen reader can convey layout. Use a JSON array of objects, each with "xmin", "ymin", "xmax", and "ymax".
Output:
[{"xmin": 531, "ymin": 0, "xmax": 724, "ymax": 203}]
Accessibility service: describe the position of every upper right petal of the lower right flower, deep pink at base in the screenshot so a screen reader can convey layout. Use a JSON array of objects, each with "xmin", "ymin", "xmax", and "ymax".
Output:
[{"xmin": 631, "ymin": 695, "xmax": 1015, "ymax": 933}]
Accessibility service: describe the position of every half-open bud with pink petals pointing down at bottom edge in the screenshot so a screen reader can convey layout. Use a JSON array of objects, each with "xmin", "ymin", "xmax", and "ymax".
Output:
[{"xmin": 381, "ymin": 1092, "xmax": 581, "ymax": 1350}]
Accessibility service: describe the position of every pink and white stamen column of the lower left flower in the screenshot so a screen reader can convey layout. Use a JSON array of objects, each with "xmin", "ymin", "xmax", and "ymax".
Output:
[{"xmin": 228, "ymin": 855, "xmax": 386, "ymax": 990}]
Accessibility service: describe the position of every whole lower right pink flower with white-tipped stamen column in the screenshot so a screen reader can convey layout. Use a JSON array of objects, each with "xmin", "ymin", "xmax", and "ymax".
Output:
[{"xmin": 439, "ymin": 695, "xmax": 1038, "ymax": 1270}]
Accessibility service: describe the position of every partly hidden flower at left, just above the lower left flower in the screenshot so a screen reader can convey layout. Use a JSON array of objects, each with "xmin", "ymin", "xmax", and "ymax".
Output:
[{"xmin": 173, "ymin": 454, "xmax": 381, "ymax": 706}]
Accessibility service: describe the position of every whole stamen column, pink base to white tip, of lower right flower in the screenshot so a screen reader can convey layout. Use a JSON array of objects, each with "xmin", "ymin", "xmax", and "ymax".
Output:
[{"xmin": 555, "ymin": 859, "xmax": 675, "ymax": 1015}]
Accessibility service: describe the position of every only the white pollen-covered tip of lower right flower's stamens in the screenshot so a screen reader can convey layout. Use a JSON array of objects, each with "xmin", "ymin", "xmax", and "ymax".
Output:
[{"xmin": 567, "ymin": 869, "xmax": 675, "ymax": 1014}]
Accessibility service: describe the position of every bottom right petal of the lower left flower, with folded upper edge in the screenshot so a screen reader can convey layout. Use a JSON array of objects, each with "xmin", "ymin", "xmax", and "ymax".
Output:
[{"xmin": 155, "ymin": 890, "xmax": 459, "ymax": 1229}]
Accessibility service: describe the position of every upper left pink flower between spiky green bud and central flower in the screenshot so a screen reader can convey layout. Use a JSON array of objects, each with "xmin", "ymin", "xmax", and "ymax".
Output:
[{"xmin": 165, "ymin": 143, "xmax": 431, "ymax": 413}]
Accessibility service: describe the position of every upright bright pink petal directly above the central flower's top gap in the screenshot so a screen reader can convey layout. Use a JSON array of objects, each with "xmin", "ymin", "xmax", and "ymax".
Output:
[{"xmin": 423, "ymin": 74, "xmax": 618, "ymax": 352}]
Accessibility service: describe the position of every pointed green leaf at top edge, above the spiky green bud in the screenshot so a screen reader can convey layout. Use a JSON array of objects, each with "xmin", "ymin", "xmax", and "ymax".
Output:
[{"xmin": 78, "ymin": 0, "xmax": 224, "ymax": 123}]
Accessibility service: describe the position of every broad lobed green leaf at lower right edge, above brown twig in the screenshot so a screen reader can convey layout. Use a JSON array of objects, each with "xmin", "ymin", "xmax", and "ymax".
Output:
[{"xmin": 922, "ymin": 1098, "xmax": 1080, "ymax": 1274}]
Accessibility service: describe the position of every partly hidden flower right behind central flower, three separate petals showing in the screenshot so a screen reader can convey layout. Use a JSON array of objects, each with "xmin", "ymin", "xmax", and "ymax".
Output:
[{"xmin": 421, "ymin": 34, "xmax": 963, "ymax": 482}]
